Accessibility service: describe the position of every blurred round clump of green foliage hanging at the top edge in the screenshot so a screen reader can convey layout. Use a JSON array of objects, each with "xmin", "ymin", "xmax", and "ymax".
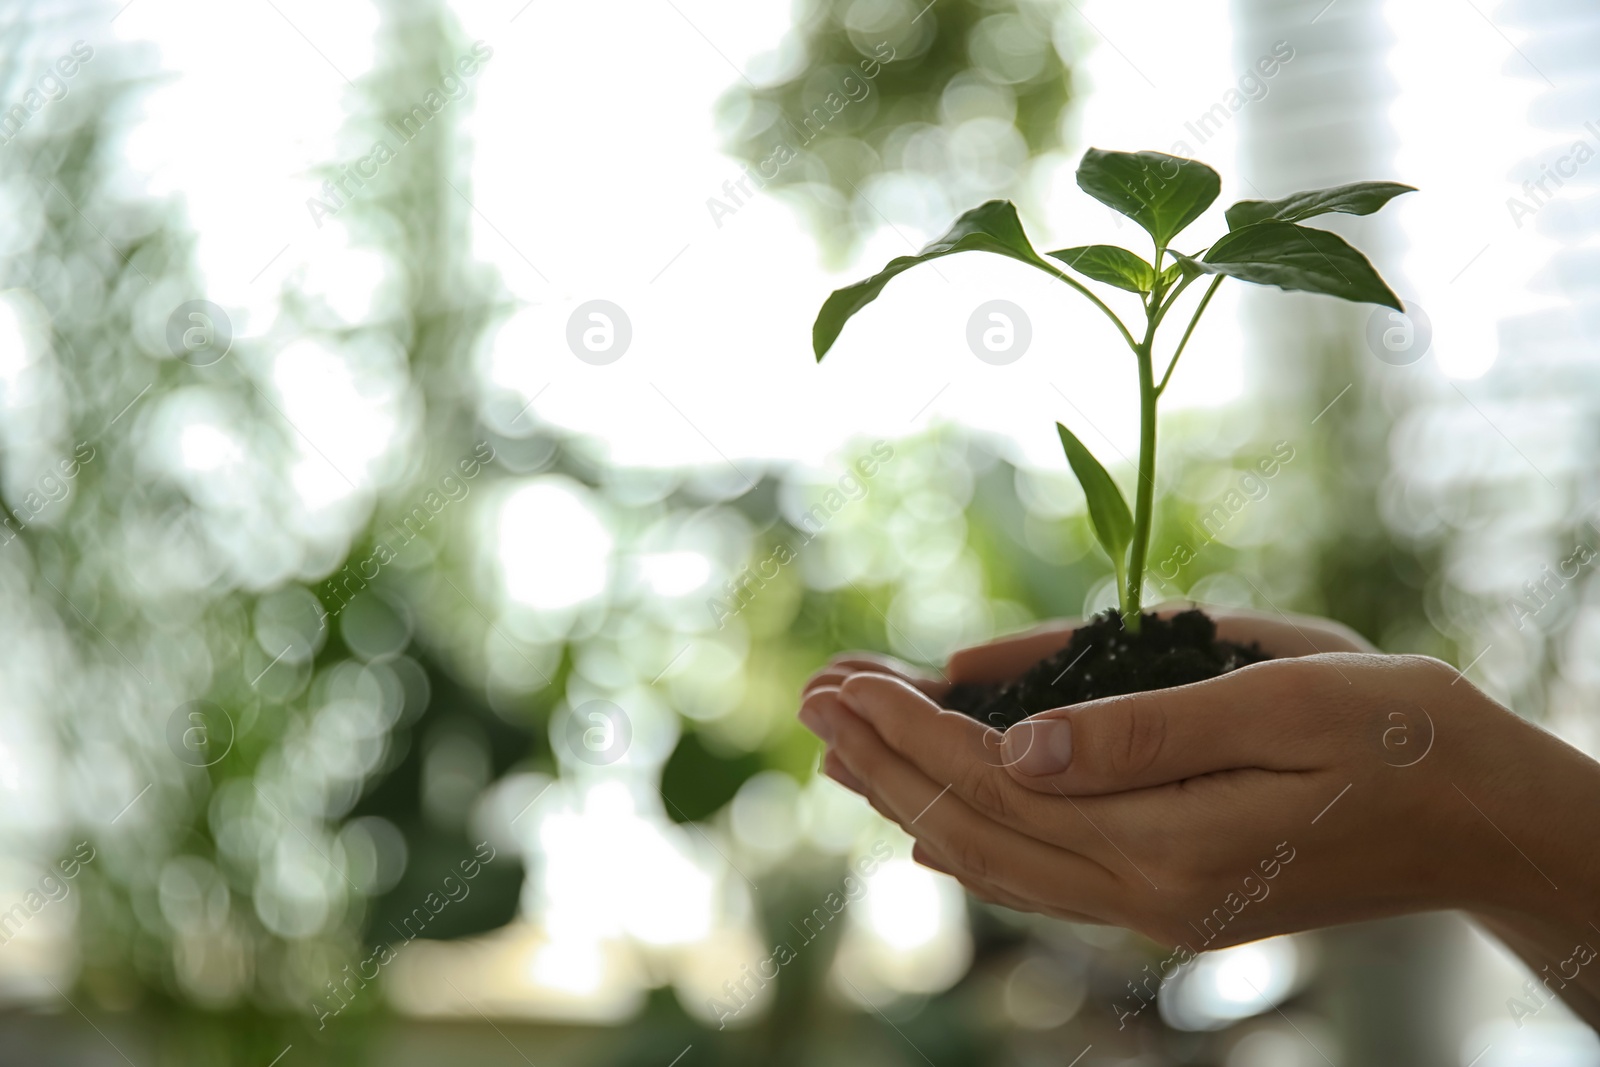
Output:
[{"xmin": 712, "ymin": 0, "xmax": 1072, "ymax": 261}]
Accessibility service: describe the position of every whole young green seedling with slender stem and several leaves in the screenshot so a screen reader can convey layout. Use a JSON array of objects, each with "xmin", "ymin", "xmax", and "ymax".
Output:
[{"xmin": 811, "ymin": 149, "xmax": 1414, "ymax": 632}]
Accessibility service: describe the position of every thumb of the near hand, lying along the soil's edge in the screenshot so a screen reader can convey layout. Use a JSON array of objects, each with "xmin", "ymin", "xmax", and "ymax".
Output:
[{"xmin": 1002, "ymin": 656, "xmax": 1347, "ymax": 795}]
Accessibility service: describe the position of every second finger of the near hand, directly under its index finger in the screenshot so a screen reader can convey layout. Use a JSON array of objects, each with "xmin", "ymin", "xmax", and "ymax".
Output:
[{"xmin": 806, "ymin": 691, "xmax": 1118, "ymax": 915}]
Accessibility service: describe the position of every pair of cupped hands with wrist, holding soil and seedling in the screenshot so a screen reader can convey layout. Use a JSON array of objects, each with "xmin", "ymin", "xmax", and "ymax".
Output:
[{"xmin": 802, "ymin": 613, "xmax": 1600, "ymax": 1019}]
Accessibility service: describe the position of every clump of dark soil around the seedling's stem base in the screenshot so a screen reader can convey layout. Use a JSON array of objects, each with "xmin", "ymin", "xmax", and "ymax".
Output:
[{"xmin": 944, "ymin": 609, "xmax": 1270, "ymax": 729}]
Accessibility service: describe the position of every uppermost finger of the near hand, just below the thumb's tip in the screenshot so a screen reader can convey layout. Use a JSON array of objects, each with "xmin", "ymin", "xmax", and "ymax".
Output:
[{"xmin": 838, "ymin": 673, "xmax": 1114, "ymax": 864}]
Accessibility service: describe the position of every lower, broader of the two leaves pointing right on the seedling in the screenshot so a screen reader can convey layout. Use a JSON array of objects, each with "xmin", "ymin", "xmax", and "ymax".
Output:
[{"xmin": 1179, "ymin": 222, "xmax": 1405, "ymax": 312}]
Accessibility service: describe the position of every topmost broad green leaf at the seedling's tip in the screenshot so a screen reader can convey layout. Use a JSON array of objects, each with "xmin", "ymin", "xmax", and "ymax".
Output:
[{"xmin": 1078, "ymin": 149, "xmax": 1222, "ymax": 248}]
